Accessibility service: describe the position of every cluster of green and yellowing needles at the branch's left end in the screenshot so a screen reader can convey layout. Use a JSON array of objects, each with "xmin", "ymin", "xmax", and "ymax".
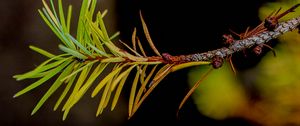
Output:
[{"xmin": 13, "ymin": 0, "xmax": 210, "ymax": 120}]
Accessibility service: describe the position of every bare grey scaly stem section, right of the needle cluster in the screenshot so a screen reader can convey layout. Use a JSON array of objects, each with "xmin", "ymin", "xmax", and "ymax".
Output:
[{"xmin": 163, "ymin": 16, "xmax": 300, "ymax": 62}]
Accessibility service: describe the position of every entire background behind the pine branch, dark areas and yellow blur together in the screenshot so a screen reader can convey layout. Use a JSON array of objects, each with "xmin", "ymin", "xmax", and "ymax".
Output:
[{"xmin": 0, "ymin": 0, "xmax": 300, "ymax": 126}]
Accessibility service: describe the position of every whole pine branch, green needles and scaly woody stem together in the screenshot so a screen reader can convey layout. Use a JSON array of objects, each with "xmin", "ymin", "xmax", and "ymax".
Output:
[{"xmin": 14, "ymin": 0, "xmax": 300, "ymax": 120}]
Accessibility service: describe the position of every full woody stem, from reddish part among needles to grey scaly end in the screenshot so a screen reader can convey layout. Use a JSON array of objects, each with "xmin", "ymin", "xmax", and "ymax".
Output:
[{"xmin": 83, "ymin": 10, "xmax": 300, "ymax": 68}]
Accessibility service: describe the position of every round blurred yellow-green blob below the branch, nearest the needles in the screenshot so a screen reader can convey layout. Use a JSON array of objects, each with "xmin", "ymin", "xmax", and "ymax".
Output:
[{"xmin": 189, "ymin": 64, "xmax": 245, "ymax": 119}]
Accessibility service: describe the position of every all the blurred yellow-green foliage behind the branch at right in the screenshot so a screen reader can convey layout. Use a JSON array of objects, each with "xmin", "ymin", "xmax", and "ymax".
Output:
[{"xmin": 189, "ymin": 0, "xmax": 300, "ymax": 126}]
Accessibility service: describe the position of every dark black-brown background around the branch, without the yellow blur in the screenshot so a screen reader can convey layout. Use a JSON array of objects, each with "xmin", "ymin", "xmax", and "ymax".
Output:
[{"xmin": 0, "ymin": 0, "xmax": 270, "ymax": 126}]
